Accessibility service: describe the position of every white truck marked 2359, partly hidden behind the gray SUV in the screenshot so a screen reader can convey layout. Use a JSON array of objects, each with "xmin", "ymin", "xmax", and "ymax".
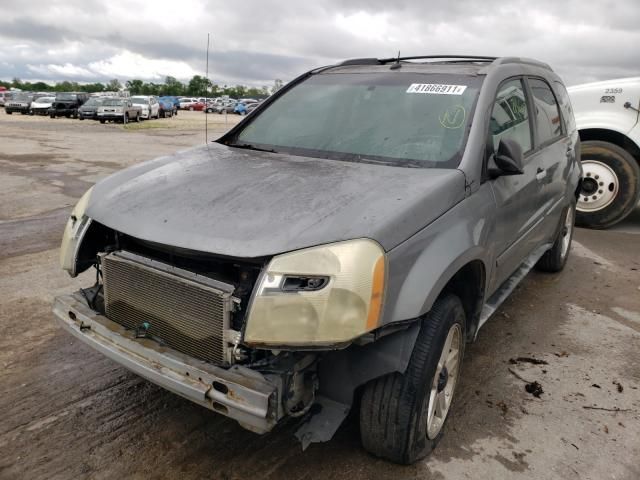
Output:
[{"xmin": 563, "ymin": 77, "xmax": 640, "ymax": 228}]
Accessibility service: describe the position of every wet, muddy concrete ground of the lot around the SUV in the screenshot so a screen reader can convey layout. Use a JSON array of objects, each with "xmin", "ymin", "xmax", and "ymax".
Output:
[{"xmin": 0, "ymin": 111, "xmax": 640, "ymax": 480}]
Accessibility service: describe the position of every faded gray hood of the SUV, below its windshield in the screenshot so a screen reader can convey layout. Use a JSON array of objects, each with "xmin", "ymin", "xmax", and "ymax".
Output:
[{"xmin": 87, "ymin": 143, "xmax": 465, "ymax": 258}]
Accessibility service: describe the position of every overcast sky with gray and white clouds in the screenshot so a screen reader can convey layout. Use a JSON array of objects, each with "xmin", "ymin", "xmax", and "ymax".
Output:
[{"xmin": 0, "ymin": 0, "xmax": 640, "ymax": 86}]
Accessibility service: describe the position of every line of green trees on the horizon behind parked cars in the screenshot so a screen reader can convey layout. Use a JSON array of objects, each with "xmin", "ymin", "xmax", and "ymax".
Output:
[{"xmin": 0, "ymin": 75, "xmax": 283, "ymax": 98}]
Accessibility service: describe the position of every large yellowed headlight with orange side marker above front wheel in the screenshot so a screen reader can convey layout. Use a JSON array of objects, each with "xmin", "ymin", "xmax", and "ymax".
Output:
[{"xmin": 244, "ymin": 239, "xmax": 386, "ymax": 347}]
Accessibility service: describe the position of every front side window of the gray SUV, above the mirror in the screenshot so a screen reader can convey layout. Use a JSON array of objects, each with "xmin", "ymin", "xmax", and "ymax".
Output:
[{"xmin": 490, "ymin": 80, "xmax": 531, "ymax": 152}]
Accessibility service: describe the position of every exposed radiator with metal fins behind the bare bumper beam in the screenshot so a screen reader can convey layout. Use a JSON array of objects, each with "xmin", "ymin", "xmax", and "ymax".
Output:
[{"xmin": 101, "ymin": 251, "xmax": 234, "ymax": 365}]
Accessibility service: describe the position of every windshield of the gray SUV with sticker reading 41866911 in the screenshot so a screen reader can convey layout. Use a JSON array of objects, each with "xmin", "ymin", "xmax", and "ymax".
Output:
[{"xmin": 235, "ymin": 72, "xmax": 481, "ymax": 168}]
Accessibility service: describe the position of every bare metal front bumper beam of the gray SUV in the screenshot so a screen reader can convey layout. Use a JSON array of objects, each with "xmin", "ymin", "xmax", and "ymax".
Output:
[{"xmin": 53, "ymin": 293, "xmax": 282, "ymax": 433}]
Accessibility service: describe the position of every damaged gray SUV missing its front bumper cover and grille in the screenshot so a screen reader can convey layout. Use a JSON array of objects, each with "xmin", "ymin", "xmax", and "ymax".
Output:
[{"xmin": 54, "ymin": 56, "xmax": 581, "ymax": 463}]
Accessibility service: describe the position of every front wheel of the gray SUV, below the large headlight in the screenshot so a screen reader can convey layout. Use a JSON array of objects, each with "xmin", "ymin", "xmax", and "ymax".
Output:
[{"xmin": 360, "ymin": 295, "xmax": 465, "ymax": 464}]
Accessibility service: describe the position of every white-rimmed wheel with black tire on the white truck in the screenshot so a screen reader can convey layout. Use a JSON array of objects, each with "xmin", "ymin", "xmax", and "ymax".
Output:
[{"xmin": 576, "ymin": 140, "xmax": 640, "ymax": 228}]
